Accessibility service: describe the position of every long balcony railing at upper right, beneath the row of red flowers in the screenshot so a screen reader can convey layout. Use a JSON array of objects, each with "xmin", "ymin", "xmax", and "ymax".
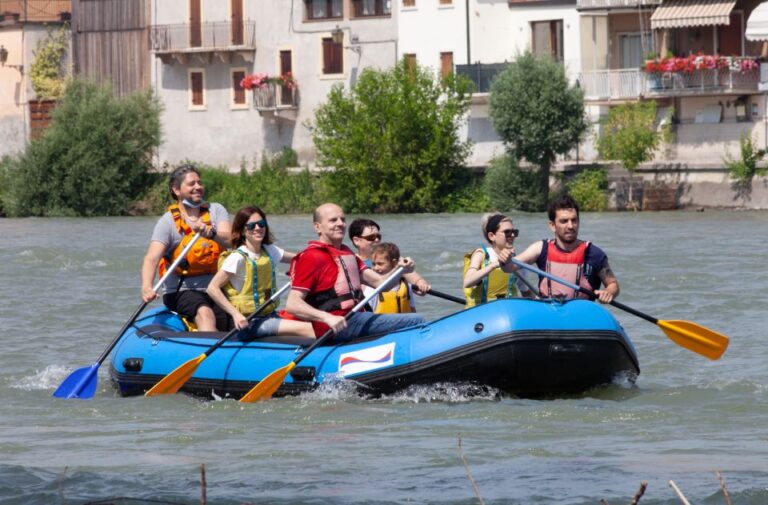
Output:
[{"xmin": 579, "ymin": 68, "xmax": 760, "ymax": 101}]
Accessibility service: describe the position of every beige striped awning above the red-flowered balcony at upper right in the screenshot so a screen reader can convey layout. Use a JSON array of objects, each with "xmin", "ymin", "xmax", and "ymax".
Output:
[{"xmin": 651, "ymin": 0, "xmax": 736, "ymax": 30}]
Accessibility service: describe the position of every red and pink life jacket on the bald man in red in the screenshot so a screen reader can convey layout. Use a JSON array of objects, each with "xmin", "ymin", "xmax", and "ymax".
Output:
[{"xmin": 300, "ymin": 242, "xmax": 363, "ymax": 315}]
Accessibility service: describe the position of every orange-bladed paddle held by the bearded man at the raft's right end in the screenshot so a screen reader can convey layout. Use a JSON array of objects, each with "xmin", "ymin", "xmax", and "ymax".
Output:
[{"xmin": 510, "ymin": 258, "xmax": 728, "ymax": 360}]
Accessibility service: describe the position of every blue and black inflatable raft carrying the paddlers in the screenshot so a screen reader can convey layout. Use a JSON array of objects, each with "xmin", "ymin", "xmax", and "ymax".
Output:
[{"xmin": 110, "ymin": 299, "xmax": 640, "ymax": 398}]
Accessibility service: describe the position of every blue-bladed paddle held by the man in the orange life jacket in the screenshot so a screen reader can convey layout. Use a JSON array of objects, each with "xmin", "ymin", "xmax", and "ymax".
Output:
[{"xmin": 53, "ymin": 233, "xmax": 200, "ymax": 400}]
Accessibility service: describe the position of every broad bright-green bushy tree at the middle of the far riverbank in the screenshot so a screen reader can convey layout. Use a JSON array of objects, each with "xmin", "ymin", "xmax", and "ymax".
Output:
[{"xmin": 311, "ymin": 61, "xmax": 471, "ymax": 212}]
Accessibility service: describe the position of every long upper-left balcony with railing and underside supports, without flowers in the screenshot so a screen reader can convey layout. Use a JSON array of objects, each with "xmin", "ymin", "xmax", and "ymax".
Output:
[{"xmin": 150, "ymin": 21, "xmax": 256, "ymax": 64}]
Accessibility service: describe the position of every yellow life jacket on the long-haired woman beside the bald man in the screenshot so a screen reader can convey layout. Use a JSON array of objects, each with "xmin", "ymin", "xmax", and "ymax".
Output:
[{"xmin": 219, "ymin": 248, "xmax": 277, "ymax": 317}]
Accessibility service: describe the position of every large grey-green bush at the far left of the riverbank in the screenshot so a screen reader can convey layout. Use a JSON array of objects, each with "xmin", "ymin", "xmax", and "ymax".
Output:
[{"xmin": 0, "ymin": 80, "xmax": 161, "ymax": 216}]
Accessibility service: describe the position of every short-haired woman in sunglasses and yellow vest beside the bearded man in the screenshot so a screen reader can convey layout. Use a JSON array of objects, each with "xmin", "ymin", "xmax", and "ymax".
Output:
[{"xmin": 464, "ymin": 213, "xmax": 530, "ymax": 308}]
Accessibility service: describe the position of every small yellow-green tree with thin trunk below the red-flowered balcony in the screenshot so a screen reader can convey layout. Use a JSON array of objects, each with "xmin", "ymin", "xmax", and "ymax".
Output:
[{"xmin": 597, "ymin": 100, "xmax": 671, "ymax": 203}]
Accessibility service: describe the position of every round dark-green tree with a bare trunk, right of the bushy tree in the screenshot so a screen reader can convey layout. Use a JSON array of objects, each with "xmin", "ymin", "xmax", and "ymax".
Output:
[{"xmin": 490, "ymin": 52, "xmax": 588, "ymax": 210}]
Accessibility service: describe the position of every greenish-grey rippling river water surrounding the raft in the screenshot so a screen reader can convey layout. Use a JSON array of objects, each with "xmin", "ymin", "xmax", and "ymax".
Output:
[{"xmin": 0, "ymin": 211, "xmax": 768, "ymax": 505}]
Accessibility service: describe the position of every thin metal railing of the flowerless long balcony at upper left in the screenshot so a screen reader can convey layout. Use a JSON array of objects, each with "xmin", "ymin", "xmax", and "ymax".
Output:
[{"xmin": 150, "ymin": 21, "xmax": 256, "ymax": 53}]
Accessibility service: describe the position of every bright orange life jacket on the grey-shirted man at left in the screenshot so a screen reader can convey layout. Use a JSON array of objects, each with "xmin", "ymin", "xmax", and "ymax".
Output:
[{"xmin": 158, "ymin": 203, "xmax": 221, "ymax": 277}]
